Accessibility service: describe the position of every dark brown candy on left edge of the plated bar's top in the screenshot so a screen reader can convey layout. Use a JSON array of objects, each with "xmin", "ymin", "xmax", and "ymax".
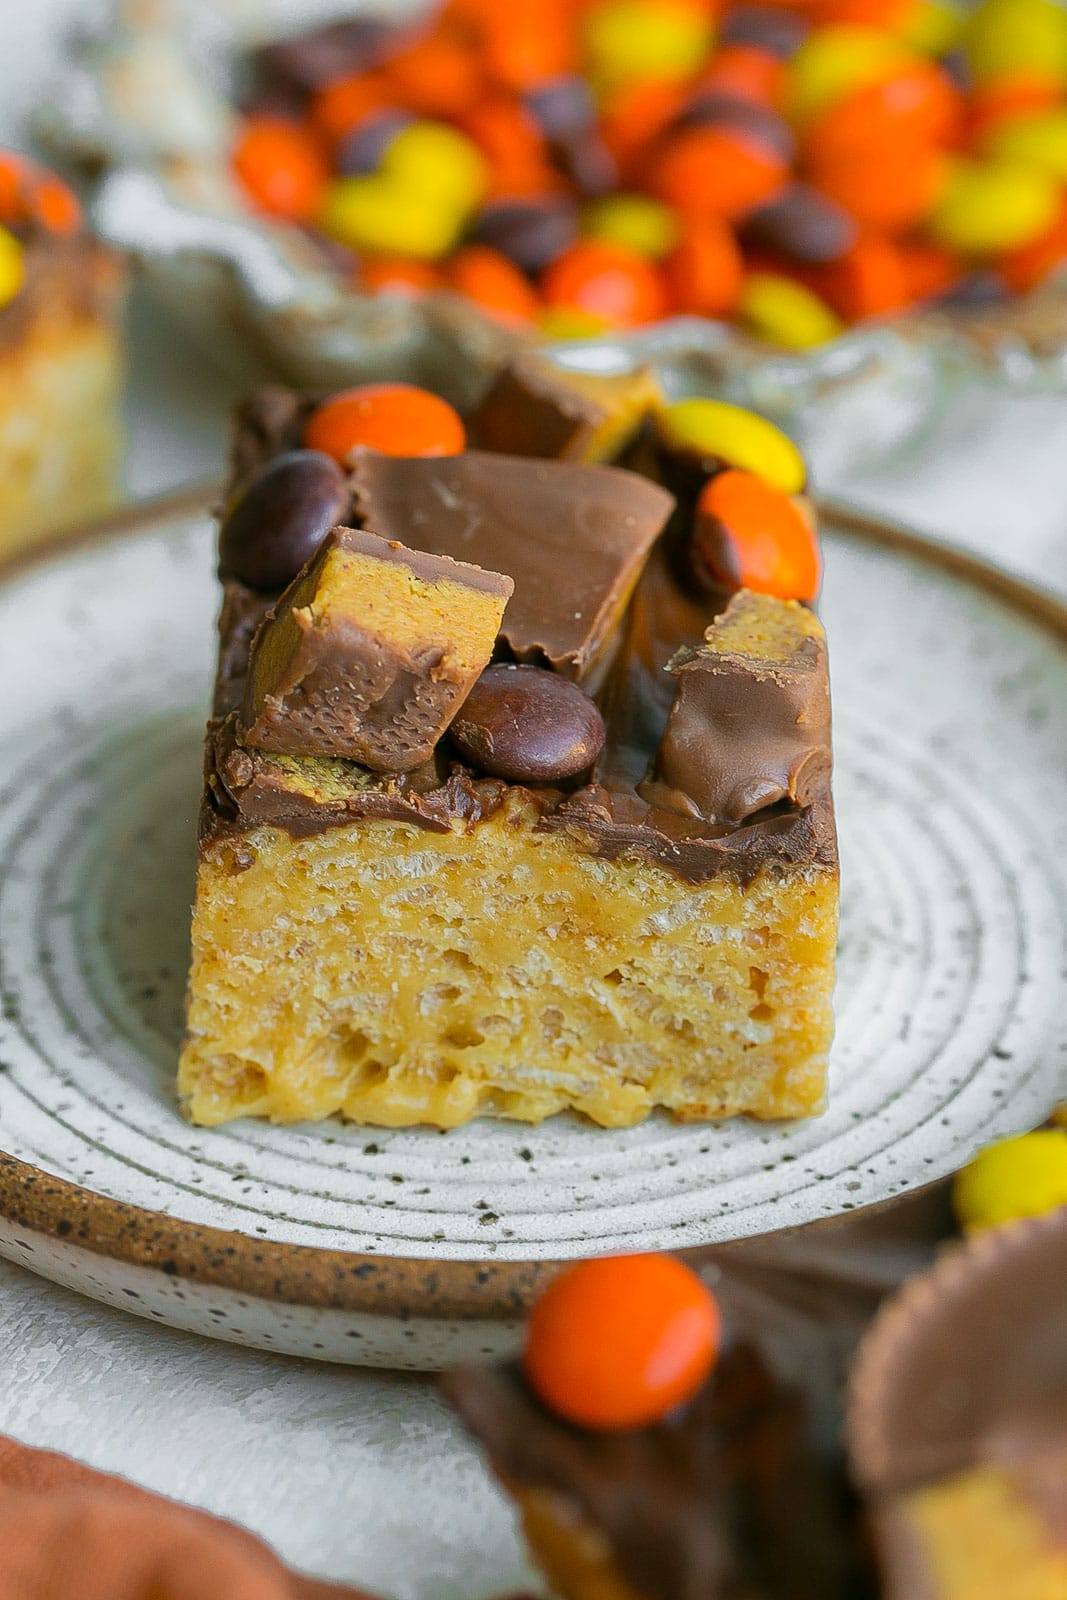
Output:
[{"xmin": 219, "ymin": 450, "xmax": 349, "ymax": 592}]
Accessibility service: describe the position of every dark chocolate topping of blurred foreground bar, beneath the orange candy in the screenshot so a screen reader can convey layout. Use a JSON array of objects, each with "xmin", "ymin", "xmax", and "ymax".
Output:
[{"xmin": 443, "ymin": 1344, "xmax": 867, "ymax": 1600}]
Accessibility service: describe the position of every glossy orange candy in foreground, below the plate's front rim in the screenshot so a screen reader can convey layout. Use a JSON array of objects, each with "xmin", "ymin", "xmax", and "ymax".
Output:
[{"xmin": 523, "ymin": 1256, "xmax": 721, "ymax": 1432}]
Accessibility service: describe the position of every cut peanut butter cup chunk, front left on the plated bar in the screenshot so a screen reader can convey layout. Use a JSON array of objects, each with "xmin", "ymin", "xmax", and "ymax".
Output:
[{"xmin": 243, "ymin": 528, "xmax": 512, "ymax": 773}]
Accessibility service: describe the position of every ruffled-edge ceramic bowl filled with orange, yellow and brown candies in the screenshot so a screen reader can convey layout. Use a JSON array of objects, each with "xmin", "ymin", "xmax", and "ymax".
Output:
[{"xmin": 42, "ymin": 0, "xmax": 1067, "ymax": 464}]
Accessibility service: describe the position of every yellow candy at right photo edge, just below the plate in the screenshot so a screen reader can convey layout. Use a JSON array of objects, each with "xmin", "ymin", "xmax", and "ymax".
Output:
[{"xmin": 952, "ymin": 1128, "xmax": 1067, "ymax": 1227}]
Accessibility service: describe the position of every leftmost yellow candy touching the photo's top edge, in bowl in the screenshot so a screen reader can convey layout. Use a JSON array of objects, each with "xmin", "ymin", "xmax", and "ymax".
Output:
[{"xmin": 585, "ymin": 0, "xmax": 713, "ymax": 86}]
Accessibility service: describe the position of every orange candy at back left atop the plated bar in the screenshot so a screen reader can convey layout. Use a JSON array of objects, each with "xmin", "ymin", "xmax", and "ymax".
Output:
[{"xmin": 304, "ymin": 384, "xmax": 467, "ymax": 466}]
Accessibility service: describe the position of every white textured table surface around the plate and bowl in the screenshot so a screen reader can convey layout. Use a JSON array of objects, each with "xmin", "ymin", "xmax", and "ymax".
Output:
[{"xmin": 0, "ymin": 0, "xmax": 1067, "ymax": 1600}]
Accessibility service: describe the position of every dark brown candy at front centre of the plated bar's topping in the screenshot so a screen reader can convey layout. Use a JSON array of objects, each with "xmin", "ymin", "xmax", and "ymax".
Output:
[{"xmin": 450, "ymin": 664, "xmax": 605, "ymax": 784}]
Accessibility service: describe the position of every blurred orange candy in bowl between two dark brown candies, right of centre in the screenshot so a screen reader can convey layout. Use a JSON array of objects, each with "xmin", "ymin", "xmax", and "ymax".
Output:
[{"xmin": 649, "ymin": 126, "xmax": 789, "ymax": 221}]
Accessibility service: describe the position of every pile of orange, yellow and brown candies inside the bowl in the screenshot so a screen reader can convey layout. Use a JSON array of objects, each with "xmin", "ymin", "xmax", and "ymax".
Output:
[{"xmin": 234, "ymin": 0, "xmax": 1067, "ymax": 349}]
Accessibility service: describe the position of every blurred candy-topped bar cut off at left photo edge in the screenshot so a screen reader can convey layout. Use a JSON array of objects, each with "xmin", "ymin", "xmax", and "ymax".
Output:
[{"xmin": 0, "ymin": 150, "xmax": 123, "ymax": 560}]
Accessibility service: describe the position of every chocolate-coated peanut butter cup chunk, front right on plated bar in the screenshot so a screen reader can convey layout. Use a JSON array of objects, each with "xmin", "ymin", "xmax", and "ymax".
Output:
[{"xmin": 638, "ymin": 592, "xmax": 830, "ymax": 822}]
